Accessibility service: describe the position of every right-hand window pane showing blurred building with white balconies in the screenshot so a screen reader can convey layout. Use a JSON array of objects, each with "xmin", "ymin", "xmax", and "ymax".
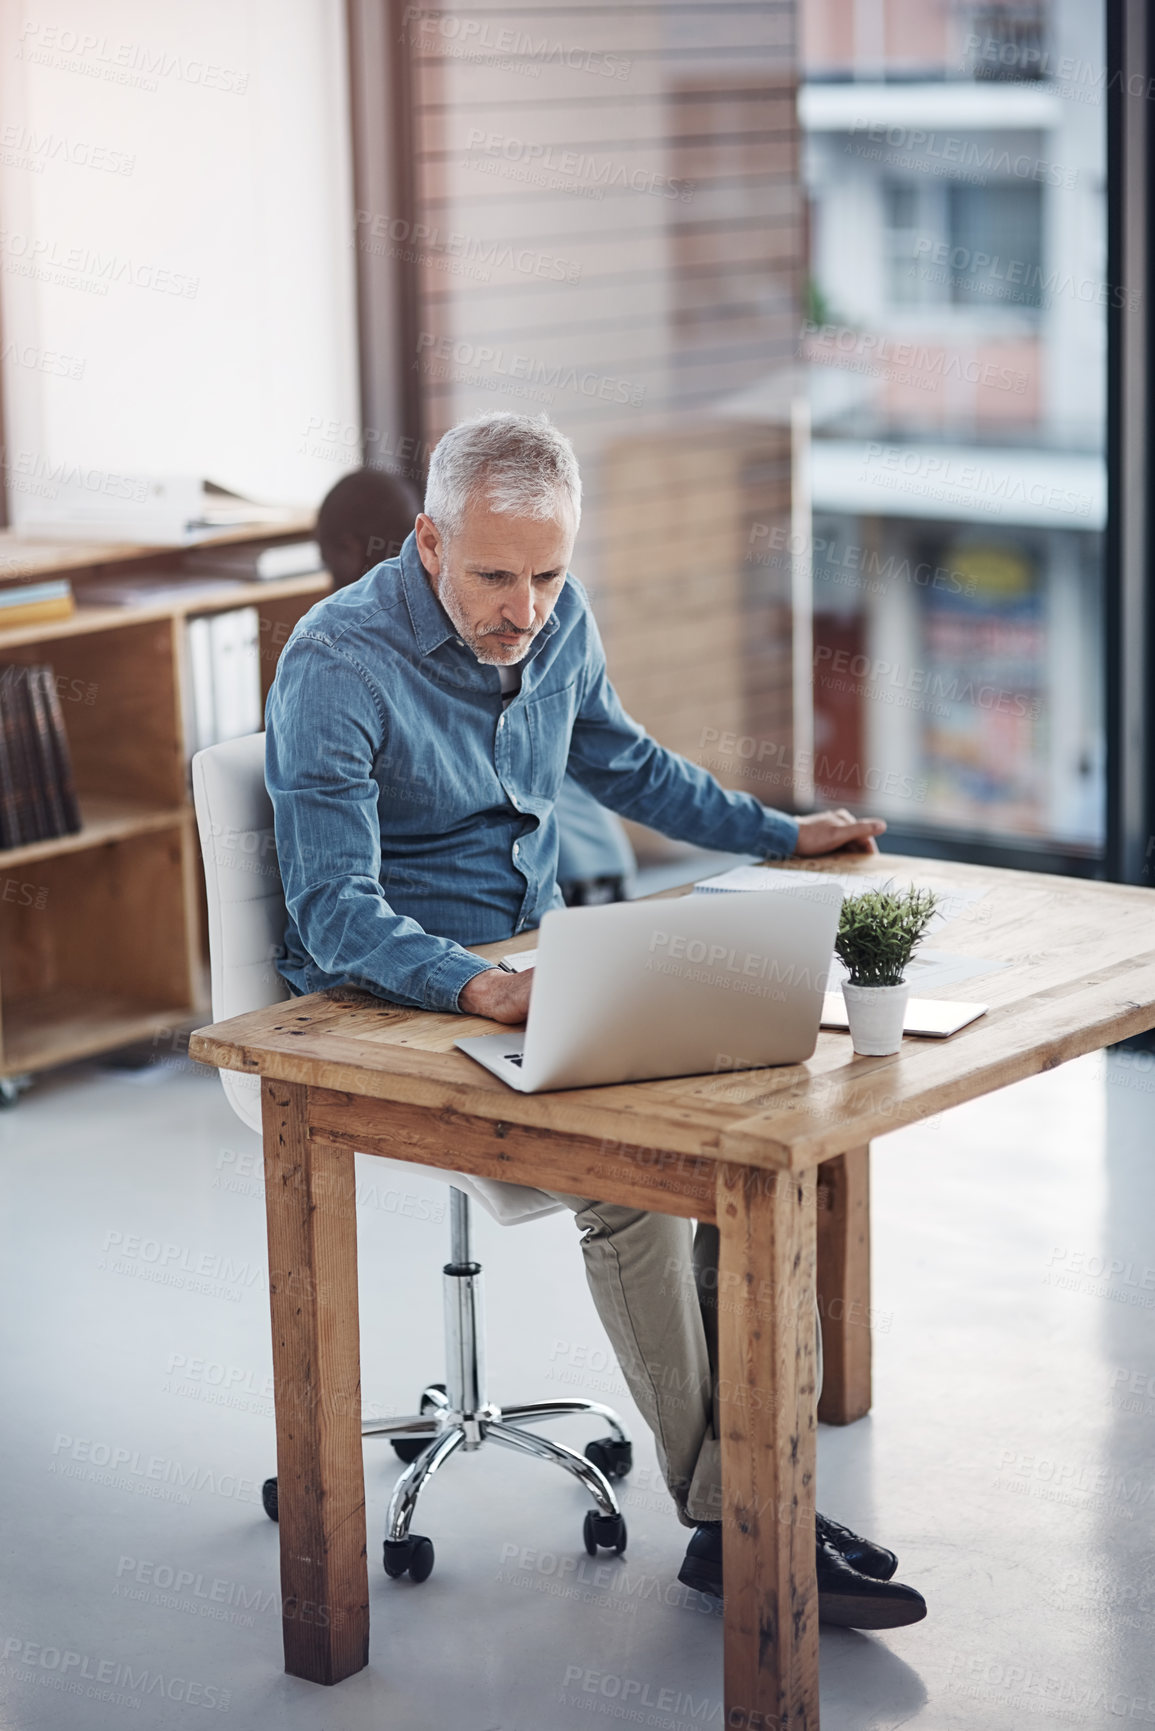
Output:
[{"xmin": 800, "ymin": 0, "xmax": 1113, "ymax": 867}]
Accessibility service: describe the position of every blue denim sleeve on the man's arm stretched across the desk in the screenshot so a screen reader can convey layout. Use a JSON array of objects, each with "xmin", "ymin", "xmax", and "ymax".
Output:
[{"xmin": 566, "ymin": 608, "xmax": 798, "ymax": 859}]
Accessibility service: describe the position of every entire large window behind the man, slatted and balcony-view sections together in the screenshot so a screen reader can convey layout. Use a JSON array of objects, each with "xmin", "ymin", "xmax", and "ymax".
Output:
[{"xmin": 358, "ymin": 0, "xmax": 1112, "ymax": 869}]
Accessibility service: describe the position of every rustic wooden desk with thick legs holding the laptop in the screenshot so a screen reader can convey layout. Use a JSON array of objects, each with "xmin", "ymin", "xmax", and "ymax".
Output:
[{"xmin": 190, "ymin": 855, "xmax": 1155, "ymax": 1731}]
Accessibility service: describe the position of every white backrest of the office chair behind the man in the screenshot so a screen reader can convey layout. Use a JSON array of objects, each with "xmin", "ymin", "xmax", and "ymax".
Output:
[{"xmin": 192, "ymin": 734, "xmax": 289, "ymax": 1130}]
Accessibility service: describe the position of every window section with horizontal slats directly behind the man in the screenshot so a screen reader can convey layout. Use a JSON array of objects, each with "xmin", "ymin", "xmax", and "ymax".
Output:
[{"xmin": 398, "ymin": 0, "xmax": 810, "ymax": 846}]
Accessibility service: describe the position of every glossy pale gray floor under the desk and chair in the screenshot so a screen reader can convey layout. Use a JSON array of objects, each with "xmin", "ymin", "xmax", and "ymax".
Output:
[{"xmin": 0, "ymin": 1052, "xmax": 1155, "ymax": 1731}]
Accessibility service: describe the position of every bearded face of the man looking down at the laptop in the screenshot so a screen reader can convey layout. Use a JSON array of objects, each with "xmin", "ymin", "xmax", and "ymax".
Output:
[{"xmin": 416, "ymin": 504, "xmax": 575, "ymax": 666}]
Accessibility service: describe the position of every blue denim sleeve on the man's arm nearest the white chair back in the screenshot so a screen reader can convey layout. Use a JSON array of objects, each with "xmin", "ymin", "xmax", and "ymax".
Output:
[{"xmin": 265, "ymin": 634, "xmax": 490, "ymax": 1011}]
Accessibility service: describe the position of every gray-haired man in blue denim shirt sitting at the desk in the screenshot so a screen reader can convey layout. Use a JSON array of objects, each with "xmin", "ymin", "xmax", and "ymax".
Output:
[{"xmin": 267, "ymin": 414, "xmax": 926, "ymax": 1629}]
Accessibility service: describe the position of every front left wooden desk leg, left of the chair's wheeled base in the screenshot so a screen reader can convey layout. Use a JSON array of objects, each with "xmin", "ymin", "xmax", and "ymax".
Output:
[{"xmin": 261, "ymin": 1078, "xmax": 369, "ymax": 1683}]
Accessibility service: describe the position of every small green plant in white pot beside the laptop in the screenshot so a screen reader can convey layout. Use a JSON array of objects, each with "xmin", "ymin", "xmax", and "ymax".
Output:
[{"xmin": 835, "ymin": 885, "xmax": 939, "ymax": 1058}]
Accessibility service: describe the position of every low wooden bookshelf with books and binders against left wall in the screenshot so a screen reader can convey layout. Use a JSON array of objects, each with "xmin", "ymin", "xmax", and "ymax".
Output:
[{"xmin": 0, "ymin": 516, "xmax": 329, "ymax": 1078}]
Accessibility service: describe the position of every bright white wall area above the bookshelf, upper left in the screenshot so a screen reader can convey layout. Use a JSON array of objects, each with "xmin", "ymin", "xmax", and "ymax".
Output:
[{"xmin": 0, "ymin": 0, "xmax": 357, "ymax": 524}]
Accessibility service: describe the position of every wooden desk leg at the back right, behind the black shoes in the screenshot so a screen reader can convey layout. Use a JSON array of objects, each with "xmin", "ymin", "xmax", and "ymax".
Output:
[{"xmin": 817, "ymin": 1144, "xmax": 871, "ymax": 1425}]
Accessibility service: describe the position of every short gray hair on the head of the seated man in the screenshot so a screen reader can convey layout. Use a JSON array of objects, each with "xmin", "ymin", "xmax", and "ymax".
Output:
[{"xmin": 424, "ymin": 414, "xmax": 582, "ymax": 540}]
